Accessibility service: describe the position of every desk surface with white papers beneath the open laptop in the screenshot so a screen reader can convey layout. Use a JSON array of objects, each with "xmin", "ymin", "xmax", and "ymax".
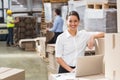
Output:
[{"xmin": 49, "ymin": 73, "xmax": 109, "ymax": 80}]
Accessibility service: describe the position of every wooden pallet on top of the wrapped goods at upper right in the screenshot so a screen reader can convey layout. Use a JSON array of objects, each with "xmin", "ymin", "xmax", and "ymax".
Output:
[{"xmin": 87, "ymin": 3, "xmax": 117, "ymax": 9}]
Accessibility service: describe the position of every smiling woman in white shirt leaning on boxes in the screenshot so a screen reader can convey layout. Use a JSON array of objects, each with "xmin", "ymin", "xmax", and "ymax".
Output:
[{"xmin": 55, "ymin": 11, "xmax": 104, "ymax": 73}]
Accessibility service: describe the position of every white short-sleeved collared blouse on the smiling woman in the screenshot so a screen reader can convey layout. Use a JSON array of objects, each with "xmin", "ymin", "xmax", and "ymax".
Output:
[{"xmin": 55, "ymin": 30, "xmax": 98, "ymax": 66}]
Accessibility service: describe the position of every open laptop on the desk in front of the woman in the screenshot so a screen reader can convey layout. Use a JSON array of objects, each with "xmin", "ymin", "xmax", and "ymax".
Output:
[{"xmin": 75, "ymin": 55, "xmax": 103, "ymax": 77}]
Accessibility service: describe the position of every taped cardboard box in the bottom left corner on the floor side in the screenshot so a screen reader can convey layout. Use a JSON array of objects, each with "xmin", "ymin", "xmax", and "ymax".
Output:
[{"xmin": 0, "ymin": 67, "xmax": 25, "ymax": 80}]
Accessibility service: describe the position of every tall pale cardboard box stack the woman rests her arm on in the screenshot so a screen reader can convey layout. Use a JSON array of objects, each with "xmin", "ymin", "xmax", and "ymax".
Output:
[{"xmin": 105, "ymin": 33, "xmax": 120, "ymax": 80}]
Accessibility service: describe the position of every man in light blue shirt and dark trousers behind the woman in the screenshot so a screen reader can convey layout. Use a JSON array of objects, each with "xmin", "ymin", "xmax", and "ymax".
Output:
[{"xmin": 46, "ymin": 9, "xmax": 63, "ymax": 44}]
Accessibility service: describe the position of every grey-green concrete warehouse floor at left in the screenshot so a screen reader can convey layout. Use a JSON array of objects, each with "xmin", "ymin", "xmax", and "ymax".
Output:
[{"xmin": 0, "ymin": 41, "xmax": 48, "ymax": 80}]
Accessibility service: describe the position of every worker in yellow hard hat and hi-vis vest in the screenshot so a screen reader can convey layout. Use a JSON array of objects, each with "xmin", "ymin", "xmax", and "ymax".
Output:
[{"xmin": 6, "ymin": 10, "xmax": 19, "ymax": 46}]
